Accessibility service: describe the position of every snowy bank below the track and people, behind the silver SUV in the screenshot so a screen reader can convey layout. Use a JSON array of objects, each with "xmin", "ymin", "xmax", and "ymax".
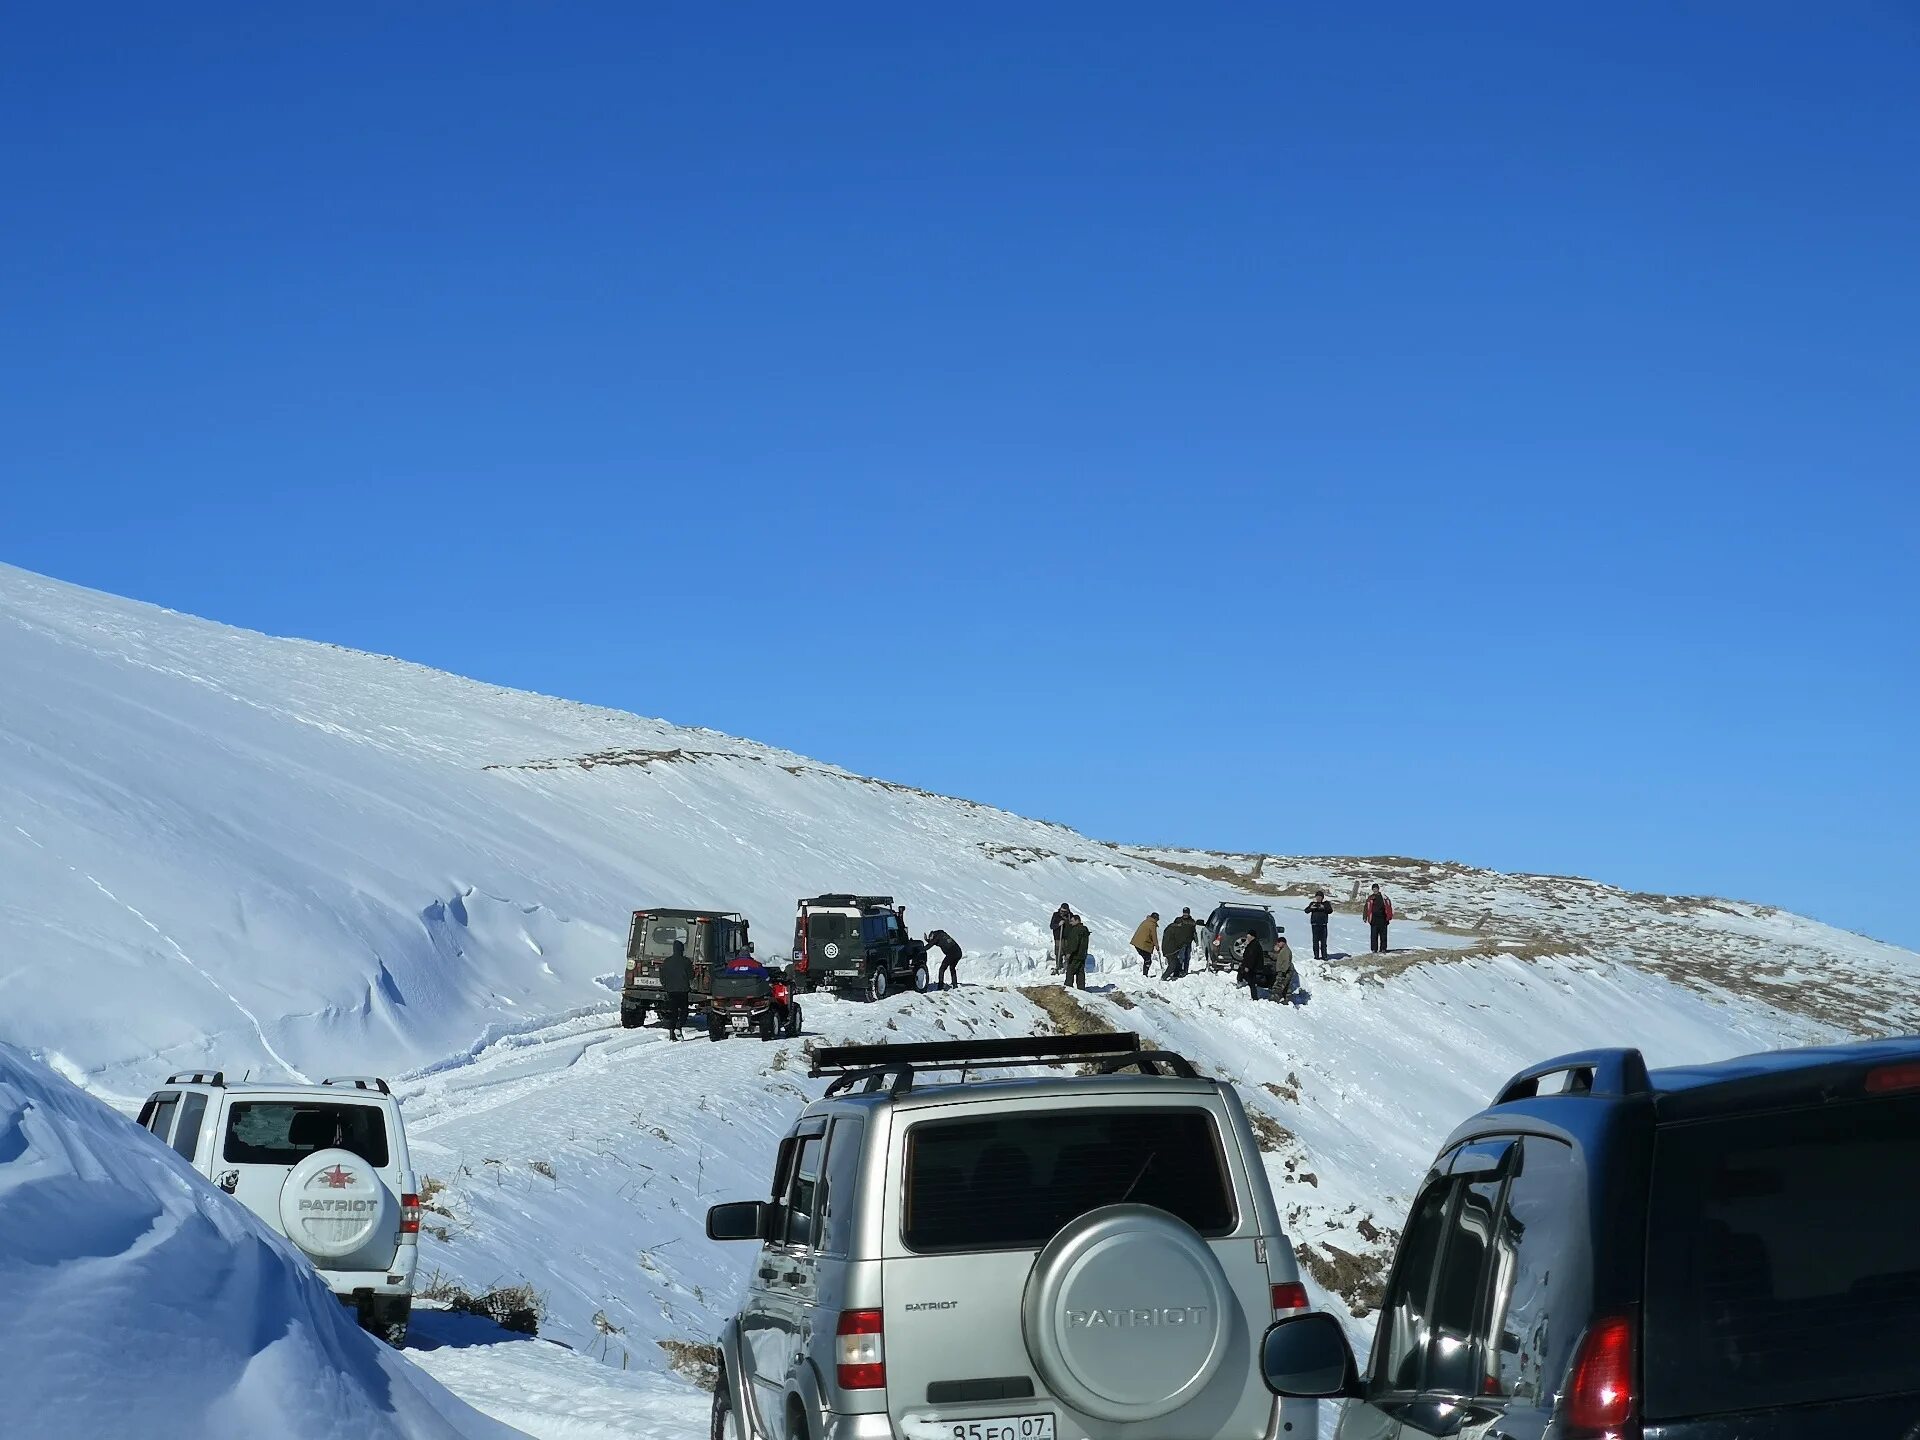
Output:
[{"xmin": 385, "ymin": 958, "xmax": 1820, "ymax": 1436}]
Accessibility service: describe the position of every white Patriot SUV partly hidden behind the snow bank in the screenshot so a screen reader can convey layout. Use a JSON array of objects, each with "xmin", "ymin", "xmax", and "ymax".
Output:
[{"xmin": 138, "ymin": 1069, "xmax": 420, "ymax": 1346}]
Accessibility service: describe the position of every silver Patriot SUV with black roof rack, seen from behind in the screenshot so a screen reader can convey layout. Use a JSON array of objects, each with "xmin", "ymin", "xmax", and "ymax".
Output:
[{"xmin": 707, "ymin": 1035, "xmax": 1317, "ymax": 1440}]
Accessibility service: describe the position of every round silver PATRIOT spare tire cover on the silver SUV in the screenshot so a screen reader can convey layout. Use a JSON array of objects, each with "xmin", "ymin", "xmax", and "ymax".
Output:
[{"xmin": 1021, "ymin": 1206, "xmax": 1236, "ymax": 1421}]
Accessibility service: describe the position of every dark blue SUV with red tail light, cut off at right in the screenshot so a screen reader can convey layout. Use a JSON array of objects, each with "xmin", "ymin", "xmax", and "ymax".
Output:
[{"xmin": 1263, "ymin": 1037, "xmax": 1920, "ymax": 1440}]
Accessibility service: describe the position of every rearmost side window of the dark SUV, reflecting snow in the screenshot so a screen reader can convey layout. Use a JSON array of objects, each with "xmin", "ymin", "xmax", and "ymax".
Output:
[{"xmin": 1486, "ymin": 1135, "xmax": 1592, "ymax": 1407}]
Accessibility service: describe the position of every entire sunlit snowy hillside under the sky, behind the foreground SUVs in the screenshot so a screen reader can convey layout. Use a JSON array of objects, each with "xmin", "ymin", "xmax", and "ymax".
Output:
[{"xmin": 0, "ymin": 568, "xmax": 1920, "ymax": 1436}]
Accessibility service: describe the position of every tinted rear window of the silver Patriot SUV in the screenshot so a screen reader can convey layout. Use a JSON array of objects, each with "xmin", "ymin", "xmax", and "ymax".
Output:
[{"xmin": 900, "ymin": 1108, "xmax": 1235, "ymax": 1252}]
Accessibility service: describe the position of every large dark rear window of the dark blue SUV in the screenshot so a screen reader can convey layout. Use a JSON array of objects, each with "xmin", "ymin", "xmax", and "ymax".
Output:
[{"xmin": 1645, "ymin": 1096, "xmax": 1920, "ymax": 1419}]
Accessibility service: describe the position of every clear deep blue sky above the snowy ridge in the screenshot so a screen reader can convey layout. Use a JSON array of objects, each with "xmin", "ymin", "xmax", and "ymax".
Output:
[{"xmin": 11, "ymin": 4, "xmax": 1920, "ymax": 945}]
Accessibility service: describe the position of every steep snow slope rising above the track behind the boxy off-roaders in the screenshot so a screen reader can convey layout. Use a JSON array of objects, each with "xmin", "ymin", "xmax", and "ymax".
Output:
[{"xmin": 0, "ymin": 566, "xmax": 1451, "ymax": 1094}]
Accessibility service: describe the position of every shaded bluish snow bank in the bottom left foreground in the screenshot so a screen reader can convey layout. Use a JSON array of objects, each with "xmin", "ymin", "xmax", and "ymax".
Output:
[{"xmin": 0, "ymin": 1044, "xmax": 515, "ymax": 1440}]
